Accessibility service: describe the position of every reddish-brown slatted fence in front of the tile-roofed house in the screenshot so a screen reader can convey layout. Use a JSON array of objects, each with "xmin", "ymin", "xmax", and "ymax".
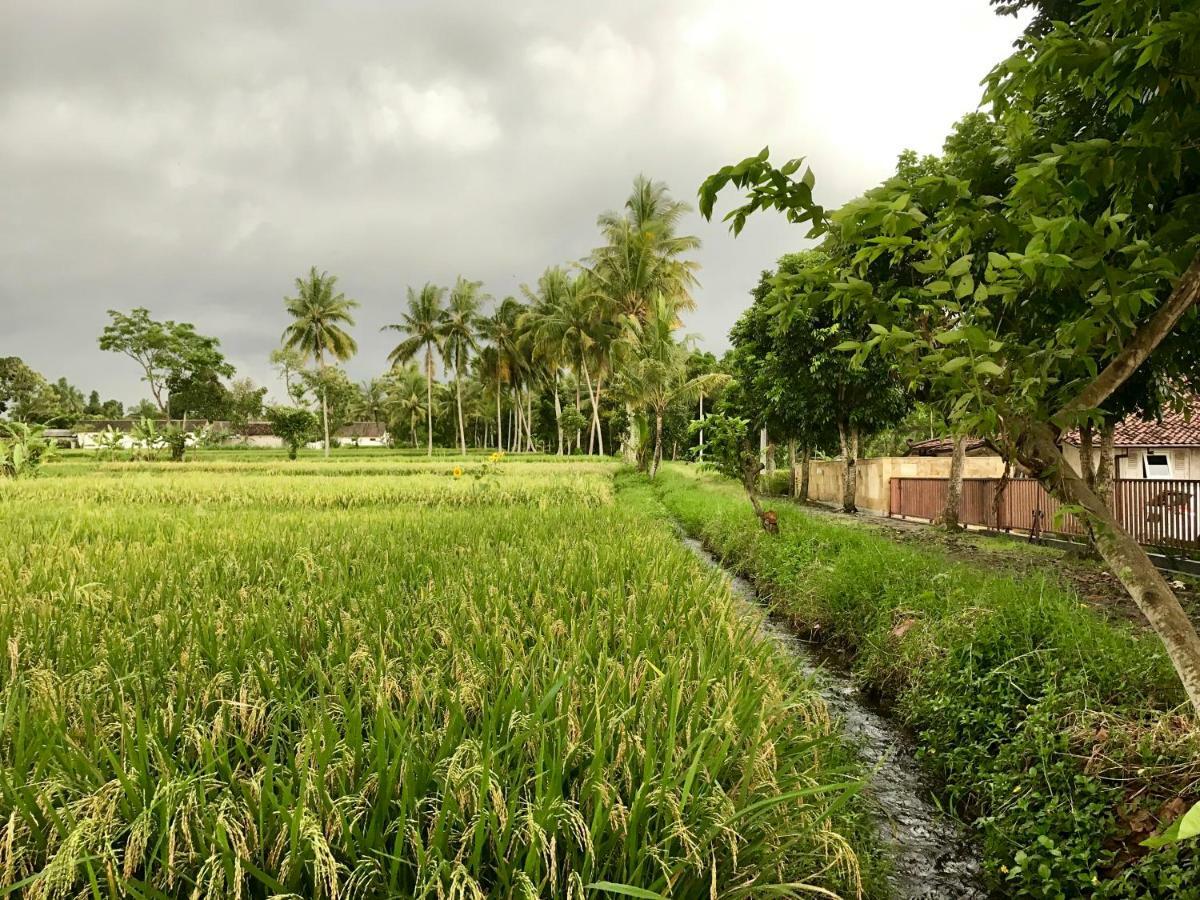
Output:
[{"xmin": 888, "ymin": 478, "xmax": 1200, "ymax": 551}]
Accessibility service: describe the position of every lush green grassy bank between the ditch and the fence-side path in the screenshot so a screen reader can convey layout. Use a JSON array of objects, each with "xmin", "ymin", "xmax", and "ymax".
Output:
[{"xmin": 658, "ymin": 467, "xmax": 1200, "ymax": 898}]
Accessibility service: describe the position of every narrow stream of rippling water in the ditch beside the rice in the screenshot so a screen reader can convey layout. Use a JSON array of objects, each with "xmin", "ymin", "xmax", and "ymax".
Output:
[{"xmin": 683, "ymin": 538, "xmax": 988, "ymax": 900}]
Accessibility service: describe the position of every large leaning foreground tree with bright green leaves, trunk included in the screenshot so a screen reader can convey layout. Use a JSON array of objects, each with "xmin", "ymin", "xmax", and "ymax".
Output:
[{"xmin": 701, "ymin": 0, "xmax": 1200, "ymax": 709}]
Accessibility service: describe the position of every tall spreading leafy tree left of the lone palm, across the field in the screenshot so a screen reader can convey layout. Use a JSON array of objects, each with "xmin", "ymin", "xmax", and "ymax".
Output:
[{"xmin": 100, "ymin": 306, "xmax": 233, "ymax": 418}]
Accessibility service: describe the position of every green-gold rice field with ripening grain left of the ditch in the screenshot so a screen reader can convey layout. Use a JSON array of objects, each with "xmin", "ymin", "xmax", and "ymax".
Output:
[{"xmin": 0, "ymin": 452, "xmax": 877, "ymax": 898}]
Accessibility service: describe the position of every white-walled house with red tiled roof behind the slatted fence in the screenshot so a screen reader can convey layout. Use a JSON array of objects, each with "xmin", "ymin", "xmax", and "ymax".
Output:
[{"xmin": 1063, "ymin": 397, "xmax": 1200, "ymax": 479}]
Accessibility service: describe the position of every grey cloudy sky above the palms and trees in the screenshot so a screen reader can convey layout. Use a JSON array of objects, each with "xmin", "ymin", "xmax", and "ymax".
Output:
[{"xmin": 0, "ymin": 0, "xmax": 1020, "ymax": 402}]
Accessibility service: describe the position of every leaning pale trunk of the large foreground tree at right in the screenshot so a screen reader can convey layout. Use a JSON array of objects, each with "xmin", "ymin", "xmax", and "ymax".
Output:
[{"xmin": 1022, "ymin": 425, "xmax": 1200, "ymax": 713}]
